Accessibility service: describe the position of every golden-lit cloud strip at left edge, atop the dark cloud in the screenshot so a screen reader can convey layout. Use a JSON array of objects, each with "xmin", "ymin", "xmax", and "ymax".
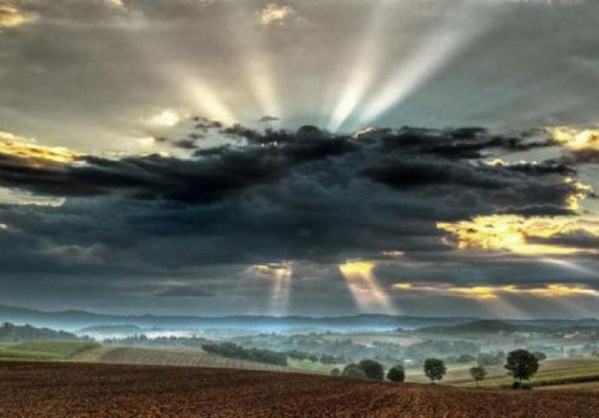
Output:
[{"xmin": 0, "ymin": 132, "xmax": 83, "ymax": 166}]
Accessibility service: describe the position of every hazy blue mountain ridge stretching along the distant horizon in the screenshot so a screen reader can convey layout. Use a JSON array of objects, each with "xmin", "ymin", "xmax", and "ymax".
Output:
[{"xmin": 0, "ymin": 306, "xmax": 599, "ymax": 332}]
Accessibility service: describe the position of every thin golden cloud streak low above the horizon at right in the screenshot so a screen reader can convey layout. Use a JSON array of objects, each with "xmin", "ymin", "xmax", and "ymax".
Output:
[{"xmin": 393, "ymin": 283, "xmax": 599, "ymax": 300}]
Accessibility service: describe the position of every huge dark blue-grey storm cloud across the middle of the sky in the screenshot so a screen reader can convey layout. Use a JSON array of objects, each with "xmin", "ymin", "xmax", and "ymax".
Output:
[{"xmin": 0, "ymin": 126, "xmax": 576, "ymax": 272}]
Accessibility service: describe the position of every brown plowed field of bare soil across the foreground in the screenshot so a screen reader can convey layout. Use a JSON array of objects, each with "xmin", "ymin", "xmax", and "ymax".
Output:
[{"xmin": 0, "ymin": 362, "xmax": 599, "ymax": 418}]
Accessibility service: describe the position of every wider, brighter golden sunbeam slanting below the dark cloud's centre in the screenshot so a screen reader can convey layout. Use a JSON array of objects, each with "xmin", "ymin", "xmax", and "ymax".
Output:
[{"xmin": 339, "ymin": 260, "xmax": 396, "ymax": 314}]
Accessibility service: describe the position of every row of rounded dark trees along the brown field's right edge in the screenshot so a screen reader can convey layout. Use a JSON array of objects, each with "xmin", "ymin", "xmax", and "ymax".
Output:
[{"xmin": 331, "ymin": 350, "xmax": 544, "ymax": 389}]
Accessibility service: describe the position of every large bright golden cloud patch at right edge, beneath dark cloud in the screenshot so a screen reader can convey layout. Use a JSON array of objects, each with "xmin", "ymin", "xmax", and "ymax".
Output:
[{"xmin": 437, "ymin": 215, "xmax": 599, "ymax": 255}]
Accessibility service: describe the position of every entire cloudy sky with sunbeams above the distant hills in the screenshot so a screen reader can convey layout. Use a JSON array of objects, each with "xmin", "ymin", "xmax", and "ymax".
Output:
[{"xmin": 0, "ymin": 0, "xmax": 599, "ymax": 318}]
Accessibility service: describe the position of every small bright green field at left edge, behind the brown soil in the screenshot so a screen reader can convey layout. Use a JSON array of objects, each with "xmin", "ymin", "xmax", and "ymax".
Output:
[{"xmin": 0, "ymin": 341, "xmax": 100, "ymax": 360}]
